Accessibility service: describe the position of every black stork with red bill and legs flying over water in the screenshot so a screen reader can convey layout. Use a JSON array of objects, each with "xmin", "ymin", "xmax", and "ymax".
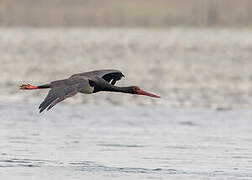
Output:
[{"xmin": 20, "ymin": 69, "xmax": 160, "ymax": 113}]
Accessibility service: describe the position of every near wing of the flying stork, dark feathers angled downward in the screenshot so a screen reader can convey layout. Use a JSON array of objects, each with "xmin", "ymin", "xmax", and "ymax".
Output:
[{"xmin": 39, "ymin": 76, "xmax": 89, "ymax": 113}]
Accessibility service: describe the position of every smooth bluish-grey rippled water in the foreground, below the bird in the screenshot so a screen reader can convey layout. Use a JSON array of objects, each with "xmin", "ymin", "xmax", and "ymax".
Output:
[{"xmin": 0, "ymin": 104, "xmax": 252, "ymax": 179}]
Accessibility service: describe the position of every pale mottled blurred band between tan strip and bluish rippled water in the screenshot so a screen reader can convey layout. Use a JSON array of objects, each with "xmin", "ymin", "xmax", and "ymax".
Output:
[{"xmin": 0, "ymin": 28, "xmax": 252, "ymax": 109}]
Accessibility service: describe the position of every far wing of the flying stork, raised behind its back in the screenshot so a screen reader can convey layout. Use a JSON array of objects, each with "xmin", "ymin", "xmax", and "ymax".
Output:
[{"xmin": 71, "ymin": 69, "xmax": 124, "ymax": 85}]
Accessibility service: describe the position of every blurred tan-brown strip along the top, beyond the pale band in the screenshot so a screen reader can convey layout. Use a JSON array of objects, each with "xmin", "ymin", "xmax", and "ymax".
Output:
[{"xmin": 0, "ymin": 0, "xmax": 252, "ymax": 28}]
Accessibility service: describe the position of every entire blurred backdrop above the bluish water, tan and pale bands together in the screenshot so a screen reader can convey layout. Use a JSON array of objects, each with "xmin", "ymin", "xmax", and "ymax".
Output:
[{"xmin": 0, "ymin": 0, "xmax": 252, "ymax": 109}]
